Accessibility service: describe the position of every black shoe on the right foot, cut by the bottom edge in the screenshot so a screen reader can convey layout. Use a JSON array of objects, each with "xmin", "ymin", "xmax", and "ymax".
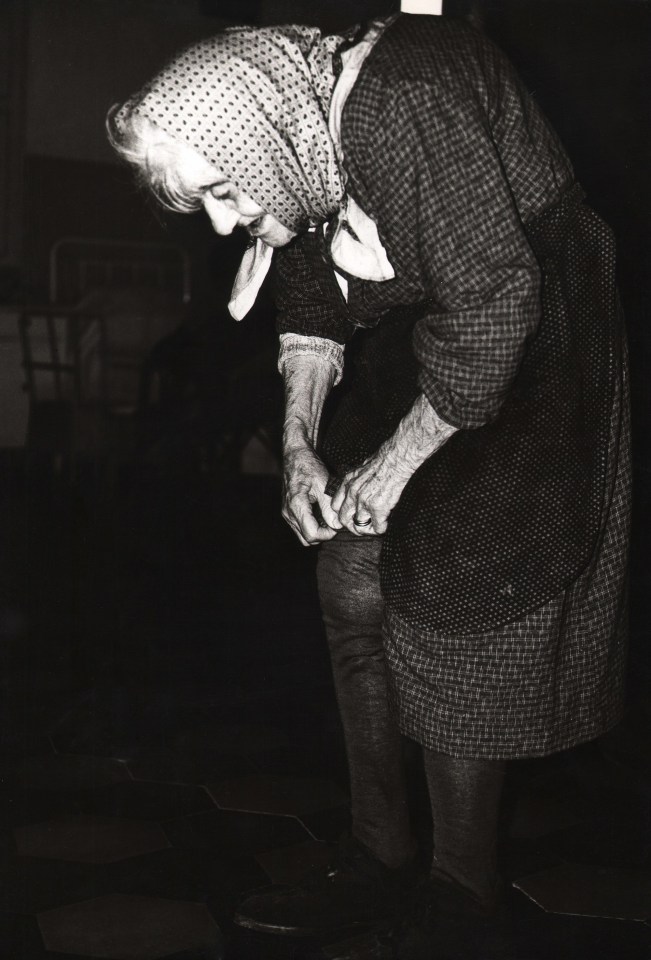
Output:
[{"xmin": 393, "ymin": 880, "xmax": 514, "ymax": 960}]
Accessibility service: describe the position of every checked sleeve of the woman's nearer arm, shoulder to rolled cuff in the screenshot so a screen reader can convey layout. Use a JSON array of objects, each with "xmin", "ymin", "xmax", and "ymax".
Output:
[{"xmin": 346, "ymin": 49, "xmax": 552, "ymax": 428}]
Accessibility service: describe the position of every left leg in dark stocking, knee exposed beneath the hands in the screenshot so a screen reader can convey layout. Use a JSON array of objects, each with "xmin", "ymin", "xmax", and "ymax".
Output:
[{"xmin": 317, "ymin": 531, "xmax": 414, "ymax": 868}]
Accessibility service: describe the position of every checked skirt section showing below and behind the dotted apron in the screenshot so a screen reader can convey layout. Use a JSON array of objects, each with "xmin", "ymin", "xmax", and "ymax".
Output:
[{"xmin": 385, "ymin": 356, "xmax": 631, "ymax": 759}]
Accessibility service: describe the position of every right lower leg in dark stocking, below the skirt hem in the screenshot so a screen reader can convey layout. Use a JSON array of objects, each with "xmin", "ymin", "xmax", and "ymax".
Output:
[{"xmin": 423, "ymin": 749, "xmax": 506, "ymax": 909}]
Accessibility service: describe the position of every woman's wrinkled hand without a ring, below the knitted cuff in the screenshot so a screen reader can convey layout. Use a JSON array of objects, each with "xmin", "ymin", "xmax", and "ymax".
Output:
[{"xmin": 282, "ymin": 445, "xmax": 341, "ymax": 547}]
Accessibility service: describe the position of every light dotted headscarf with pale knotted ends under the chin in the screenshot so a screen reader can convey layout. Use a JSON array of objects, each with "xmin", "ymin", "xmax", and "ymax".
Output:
[{"xmin": 114, "ymin": 18, "xmax": 393, "ymax": 320}]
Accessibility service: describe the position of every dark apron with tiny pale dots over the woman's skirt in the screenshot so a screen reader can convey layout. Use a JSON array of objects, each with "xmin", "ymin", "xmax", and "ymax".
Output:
[{"xmin": 382, "ymin": 190, "xmax": 621, "ymax": 633}]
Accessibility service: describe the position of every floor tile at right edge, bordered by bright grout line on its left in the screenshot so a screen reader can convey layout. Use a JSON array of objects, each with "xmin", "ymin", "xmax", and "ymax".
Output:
[{"xmin": 515, "ymin": 863, "xmax": 651, "ymax": 921}]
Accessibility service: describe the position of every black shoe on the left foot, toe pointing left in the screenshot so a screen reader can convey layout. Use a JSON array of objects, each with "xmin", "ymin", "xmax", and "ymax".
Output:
[{"xmin": 233, "ymin": 838, "xmax": 422, "ymax": 937}]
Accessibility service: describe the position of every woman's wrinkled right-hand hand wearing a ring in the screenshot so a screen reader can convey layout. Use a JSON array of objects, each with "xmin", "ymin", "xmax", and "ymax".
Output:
[{"xmin": 332, "ymin": 448, "xmax": 412, "ymax": 536}]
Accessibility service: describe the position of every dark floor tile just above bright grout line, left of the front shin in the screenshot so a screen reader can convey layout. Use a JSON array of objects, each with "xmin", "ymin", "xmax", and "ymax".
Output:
[{"xmin": 208, "ymin": 775, "xmax": 347, "ymax": 816}]
